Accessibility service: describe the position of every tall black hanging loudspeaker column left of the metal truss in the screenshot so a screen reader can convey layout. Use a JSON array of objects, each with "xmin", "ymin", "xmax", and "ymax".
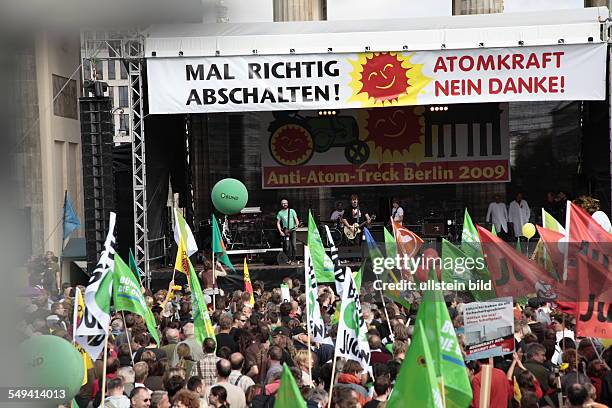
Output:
[{"xmin": 79, "ymin": 97, "xmax": 115, "ymax": 274}]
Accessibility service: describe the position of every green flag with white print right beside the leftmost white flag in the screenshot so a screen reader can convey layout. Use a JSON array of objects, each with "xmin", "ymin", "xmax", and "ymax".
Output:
[{"xmin": 113, "ymin": 254, "xmax": 161, "ymax": 345}]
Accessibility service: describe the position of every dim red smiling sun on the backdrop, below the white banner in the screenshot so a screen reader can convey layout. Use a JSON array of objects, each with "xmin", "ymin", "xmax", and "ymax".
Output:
[{"xmin": 358, "ymin": 106, "xmax": 425, "ymax": 164}]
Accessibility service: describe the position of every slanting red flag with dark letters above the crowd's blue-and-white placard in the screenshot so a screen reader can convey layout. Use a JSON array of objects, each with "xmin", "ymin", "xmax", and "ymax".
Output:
[{"xmin": 477, "ymin": 226, "xmax": 567, "ymax": 301}]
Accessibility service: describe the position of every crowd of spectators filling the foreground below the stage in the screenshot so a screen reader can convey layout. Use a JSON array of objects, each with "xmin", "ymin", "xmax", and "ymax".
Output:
[{"xmin": 16, "ymin": 270, "xmax": 612, "ymax": 408}]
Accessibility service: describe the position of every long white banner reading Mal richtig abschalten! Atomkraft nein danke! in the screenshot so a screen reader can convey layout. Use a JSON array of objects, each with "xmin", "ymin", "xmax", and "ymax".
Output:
[{"xmin": 147, "ymin": 43, "xmax": 606, "ymax": 114}]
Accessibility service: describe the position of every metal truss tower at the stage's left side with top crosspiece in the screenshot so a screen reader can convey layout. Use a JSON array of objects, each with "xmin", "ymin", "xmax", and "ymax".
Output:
[{"xmin": 81, "ymin": 30, "xmax": 151, "ymax": 288}]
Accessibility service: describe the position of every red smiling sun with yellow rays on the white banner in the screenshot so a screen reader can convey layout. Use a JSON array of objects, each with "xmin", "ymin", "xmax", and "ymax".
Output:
[{"xmin": 350, "ymin": 52, "xmax": 431, "ymax": 107}]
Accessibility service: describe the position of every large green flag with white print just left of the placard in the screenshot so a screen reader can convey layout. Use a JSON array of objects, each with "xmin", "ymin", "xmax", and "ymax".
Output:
[{"xmin": 418, "ymin": 270, "xmax": 472, "ymax": 408}]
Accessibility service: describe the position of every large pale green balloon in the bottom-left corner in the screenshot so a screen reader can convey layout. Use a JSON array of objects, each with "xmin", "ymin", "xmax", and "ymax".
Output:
[{"xmin": 19, "ymin": 335, "xmax": 84, "ymax": 402}]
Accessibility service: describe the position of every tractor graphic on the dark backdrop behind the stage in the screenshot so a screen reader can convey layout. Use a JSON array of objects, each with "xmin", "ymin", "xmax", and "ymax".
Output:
[{"xmin": 268, "ymin": 111, "xmax": 370, "ymax": 166}]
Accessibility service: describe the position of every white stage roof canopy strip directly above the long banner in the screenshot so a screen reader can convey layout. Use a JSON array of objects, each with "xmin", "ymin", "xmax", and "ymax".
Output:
[{"xmin": 145, "ymin": 7, "xmax": 609, "ymax": 58}]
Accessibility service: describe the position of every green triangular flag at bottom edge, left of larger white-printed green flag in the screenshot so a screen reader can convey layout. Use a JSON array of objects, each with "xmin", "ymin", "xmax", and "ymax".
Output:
[{"xmin": 386, "ymin": 319, "xmax": 444, "ymax": 408}]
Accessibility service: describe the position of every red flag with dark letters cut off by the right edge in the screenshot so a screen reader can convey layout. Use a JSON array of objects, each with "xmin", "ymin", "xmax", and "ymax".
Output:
[{"xmin": 576, "ymin": 255, "xmax": 612, "ymax": 339}]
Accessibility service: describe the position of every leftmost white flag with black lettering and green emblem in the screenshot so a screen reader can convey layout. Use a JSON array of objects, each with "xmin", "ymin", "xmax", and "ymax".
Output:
[{"xmin": 76, "ymin": 212, "xmax": 116, "ymax": 360}]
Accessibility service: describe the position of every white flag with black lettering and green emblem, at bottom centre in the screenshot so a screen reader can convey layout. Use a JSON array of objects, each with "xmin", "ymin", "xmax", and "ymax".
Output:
[{"xmin": 335, "ymin": 268, "xmax": 372, "ymax": 375}]
